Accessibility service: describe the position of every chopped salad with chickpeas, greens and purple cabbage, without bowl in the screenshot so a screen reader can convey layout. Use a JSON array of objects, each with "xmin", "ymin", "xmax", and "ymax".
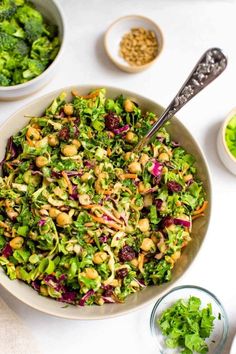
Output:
[{"xmin": 0, "ymin": 89, "xmax": 207, "ymax": 306}]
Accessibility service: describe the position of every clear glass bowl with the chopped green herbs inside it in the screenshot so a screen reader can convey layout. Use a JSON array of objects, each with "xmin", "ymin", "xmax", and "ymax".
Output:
[{"xmin": 150, "ymin": 285, "xmax": 228, "ymax": 354}]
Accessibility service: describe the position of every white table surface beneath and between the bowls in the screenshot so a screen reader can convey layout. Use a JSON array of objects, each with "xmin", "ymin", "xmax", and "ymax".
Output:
[{"xmin": 0, "ymin": 0, "xmax": 236, "ymax": 354}]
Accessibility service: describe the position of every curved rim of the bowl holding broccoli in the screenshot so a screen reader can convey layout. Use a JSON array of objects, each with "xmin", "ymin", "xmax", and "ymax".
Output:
[{"xmin": 0, "ymin": 0, "xmax": 67, "ymax": 93}]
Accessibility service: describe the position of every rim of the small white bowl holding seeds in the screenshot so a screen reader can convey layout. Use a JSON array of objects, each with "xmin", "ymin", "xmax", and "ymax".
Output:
[{"xmin": 104, "ymin": 14, "xmax": 164, "ymax": 72}]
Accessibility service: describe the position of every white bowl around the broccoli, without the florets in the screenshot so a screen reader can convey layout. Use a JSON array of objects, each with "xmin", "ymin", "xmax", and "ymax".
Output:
[{"xmin": 0, "ymin": 0, "xmax": 65, "ymax": 101}]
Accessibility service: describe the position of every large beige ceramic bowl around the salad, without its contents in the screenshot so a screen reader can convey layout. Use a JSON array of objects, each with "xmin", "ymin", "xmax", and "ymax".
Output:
[{"xmin": 0, "ymin": 86, "xmax": 211, "ymax": 319}]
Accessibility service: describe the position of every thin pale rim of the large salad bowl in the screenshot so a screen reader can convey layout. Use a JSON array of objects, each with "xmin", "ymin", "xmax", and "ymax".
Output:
[{"xmin": 0, "ymin": 84, "xmax": 213, "ymax": 320}]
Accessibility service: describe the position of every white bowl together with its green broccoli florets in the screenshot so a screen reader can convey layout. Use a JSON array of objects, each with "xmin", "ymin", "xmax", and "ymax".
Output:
[{"xmin": 0, "ymin": 0, "xmax": 65, "ymax": 100}]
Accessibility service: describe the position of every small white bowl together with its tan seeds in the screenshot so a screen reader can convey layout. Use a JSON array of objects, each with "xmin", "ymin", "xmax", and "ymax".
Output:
[{"xmin": 104, "ymin": 15, "xmax": 163, "ymax": 73}]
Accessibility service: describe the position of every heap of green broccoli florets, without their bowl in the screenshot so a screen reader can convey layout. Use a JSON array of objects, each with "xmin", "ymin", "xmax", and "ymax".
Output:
[{"xmin": 0, "ymin": 0, "xmax": 60, "ymax": 86}]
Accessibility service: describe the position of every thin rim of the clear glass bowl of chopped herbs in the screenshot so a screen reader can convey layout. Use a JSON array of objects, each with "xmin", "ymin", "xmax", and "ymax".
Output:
[{"xmin": 149, "ymin": 285, "xmax": 229, "ymax": 354}]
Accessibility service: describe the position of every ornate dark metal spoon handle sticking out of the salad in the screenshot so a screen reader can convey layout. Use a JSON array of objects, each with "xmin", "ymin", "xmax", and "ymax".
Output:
[{"xmin": 134, "ymin": 48, "xmax": 227, "ymax": 153}]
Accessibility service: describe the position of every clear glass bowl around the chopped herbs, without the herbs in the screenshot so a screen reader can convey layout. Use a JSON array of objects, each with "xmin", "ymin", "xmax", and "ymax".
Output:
[{"xmin": 150, "ymin": 285, "xmax": 229, "ymax": 354}]
